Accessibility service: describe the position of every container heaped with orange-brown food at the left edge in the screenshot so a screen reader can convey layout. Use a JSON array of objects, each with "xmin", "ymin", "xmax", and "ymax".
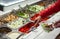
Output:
[{"xmin": 0, "ymin": 12, "xmax": 18, "ymax": 26}]
